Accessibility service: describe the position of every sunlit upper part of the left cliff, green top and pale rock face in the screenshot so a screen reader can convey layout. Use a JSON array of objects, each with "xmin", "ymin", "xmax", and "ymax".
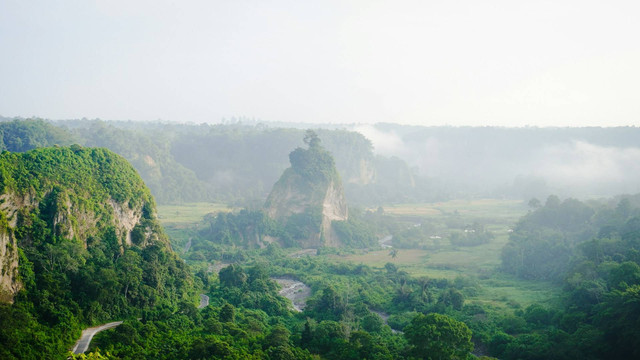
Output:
[{"xmin": 0, "ymin": 147, "xmax": 162, "ymax": 302}]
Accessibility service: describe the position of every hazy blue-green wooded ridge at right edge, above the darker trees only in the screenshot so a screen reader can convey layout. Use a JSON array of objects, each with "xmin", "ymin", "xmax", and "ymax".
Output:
[{"xmin": 502, "ymin": 195, "xmax": 640, "ymax": 281}]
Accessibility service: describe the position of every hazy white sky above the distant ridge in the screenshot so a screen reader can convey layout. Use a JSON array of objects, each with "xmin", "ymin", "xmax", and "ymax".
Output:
[{"xmin": 0, "ymin": 0, "xmax": 640, "ymax": 126}]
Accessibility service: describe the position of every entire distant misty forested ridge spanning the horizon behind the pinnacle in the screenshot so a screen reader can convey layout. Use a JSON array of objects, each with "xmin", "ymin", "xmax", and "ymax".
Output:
[{"xmin": 0, "ymin": 118, "xmax": 640, "ymax": 205}]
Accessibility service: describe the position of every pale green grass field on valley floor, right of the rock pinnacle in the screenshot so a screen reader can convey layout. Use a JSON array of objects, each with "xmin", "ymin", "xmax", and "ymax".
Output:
[{"xmin": 340, "ymin": 199, "xmax": 559, "ymax": 309}]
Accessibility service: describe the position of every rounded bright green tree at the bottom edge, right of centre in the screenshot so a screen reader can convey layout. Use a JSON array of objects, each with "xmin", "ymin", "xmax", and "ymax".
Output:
[{"xmin": 404, "ymin": 313, "xmax": 473, "ymax": 360}]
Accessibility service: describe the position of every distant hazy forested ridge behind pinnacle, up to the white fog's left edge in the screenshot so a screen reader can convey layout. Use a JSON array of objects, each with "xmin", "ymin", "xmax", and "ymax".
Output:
[{"xmin": 0, "ymin": 119, "xmax": 424, "ymax": 208}]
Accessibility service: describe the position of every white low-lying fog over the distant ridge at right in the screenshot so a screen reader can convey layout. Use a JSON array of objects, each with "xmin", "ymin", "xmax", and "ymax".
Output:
[{"xmin": 354, "ymin": 124, "xmax": 640, "ymax": 197}]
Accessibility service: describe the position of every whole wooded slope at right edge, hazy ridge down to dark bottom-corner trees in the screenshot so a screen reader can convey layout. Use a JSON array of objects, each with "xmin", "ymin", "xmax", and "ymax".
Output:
[{"xmin": 490, "ymin": 195, "xmax": 640, "ymax": 359}]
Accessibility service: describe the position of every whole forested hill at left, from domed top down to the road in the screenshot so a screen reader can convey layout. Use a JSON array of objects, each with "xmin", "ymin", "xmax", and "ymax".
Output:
[{"xmin": 0, "ymin": 145, "xmax": 195, "ymax": 359}]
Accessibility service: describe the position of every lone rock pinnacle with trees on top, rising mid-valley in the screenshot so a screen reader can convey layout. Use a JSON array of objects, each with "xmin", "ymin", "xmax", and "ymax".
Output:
[{"xmin": 265, "ymin": 132, "xmax": 348, "ymax": 248}]
